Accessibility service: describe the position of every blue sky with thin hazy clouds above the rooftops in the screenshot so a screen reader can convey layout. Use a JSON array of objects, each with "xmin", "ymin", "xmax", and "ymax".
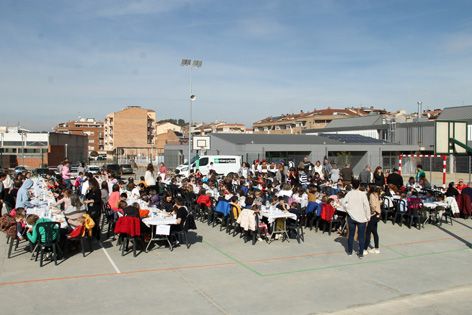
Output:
[{"xmin": 0, "ymin": 0, "xmax": 472, "ymax": 130}]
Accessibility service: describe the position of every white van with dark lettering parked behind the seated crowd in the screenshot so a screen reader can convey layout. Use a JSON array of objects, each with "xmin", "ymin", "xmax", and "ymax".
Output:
[{"xmin": 176, "ymin": 155, "xmax": 241, "ymax": 176}]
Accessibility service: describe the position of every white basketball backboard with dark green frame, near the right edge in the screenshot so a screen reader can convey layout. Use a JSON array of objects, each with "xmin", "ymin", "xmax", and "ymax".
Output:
[{"xmin": 435, "ymin": 121, "xmax": 467, "ymax": 154}]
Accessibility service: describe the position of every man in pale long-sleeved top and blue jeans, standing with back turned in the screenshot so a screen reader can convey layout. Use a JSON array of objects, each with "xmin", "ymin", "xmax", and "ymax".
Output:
[{"xmin": 343, "ymin": 179, "xmax": 370, "ymax": 258}]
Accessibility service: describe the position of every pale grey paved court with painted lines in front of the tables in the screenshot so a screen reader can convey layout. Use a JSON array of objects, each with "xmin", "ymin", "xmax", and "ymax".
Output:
[{"xmin": 0, "ymin": 219, "xmax": 472, "ymax": 315}]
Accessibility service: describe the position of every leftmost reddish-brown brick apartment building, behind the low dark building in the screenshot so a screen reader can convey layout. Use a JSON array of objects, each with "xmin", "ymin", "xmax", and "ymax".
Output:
[{"xmin": 54, "ymin": 118, "xmax": 105, "ymax": 153}]
